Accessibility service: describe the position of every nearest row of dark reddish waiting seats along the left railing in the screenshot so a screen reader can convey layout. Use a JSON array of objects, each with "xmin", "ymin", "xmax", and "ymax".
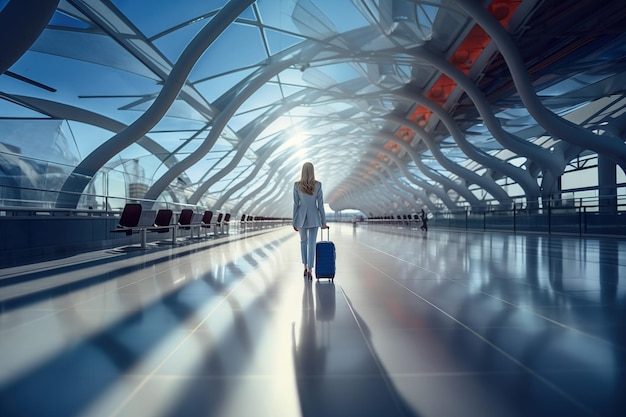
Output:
[{"xmin": 111, "ymin": 203, "xmax": 230, "ymax": 247}]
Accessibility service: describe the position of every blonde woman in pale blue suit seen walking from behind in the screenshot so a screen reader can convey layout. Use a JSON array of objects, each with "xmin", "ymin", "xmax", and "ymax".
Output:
[{"xmin": 293, "ymin": 162, "xmax": 328, "ymax": 279}]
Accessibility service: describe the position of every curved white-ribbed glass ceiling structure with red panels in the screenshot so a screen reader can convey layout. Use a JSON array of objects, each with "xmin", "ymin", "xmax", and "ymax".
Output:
[{"xmin": 0, "ymin": 0, "xmax": 626, "ymax": 217}]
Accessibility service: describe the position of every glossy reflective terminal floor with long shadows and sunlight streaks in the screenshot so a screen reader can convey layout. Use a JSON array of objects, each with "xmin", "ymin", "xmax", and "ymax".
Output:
[{"xmin": 0, "ymin": 224, "xmax": 626, "ymax": 417}]
